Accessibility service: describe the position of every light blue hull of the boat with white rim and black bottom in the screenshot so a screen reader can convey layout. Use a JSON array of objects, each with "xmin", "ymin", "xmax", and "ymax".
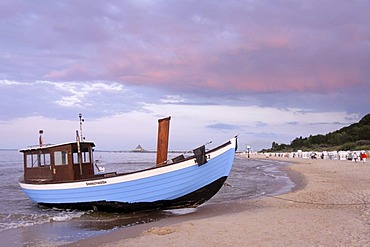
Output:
[{"xmin": 20, "ymin": 138, "xmax": 236, "ymax": 212}]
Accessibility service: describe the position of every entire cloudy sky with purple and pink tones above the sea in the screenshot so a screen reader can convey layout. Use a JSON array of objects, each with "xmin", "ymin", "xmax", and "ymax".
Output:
[{"xmin": 0, "ymin": 0, "xmax": 370, "ymax": 150}]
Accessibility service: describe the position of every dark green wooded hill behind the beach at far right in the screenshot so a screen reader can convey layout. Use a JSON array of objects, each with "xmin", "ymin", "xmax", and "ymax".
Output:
[{"xmin": 262, "ymin": 114, "xmax": 370, "ymax": 152}]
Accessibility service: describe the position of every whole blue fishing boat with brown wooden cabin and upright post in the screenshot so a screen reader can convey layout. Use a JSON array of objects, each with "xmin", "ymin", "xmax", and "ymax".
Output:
[{"xmin": 19, "ymin": 114, "xmax": 237, "ymax": 212}]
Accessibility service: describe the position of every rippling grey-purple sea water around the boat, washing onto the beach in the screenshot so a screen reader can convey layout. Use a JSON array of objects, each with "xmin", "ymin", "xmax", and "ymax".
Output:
[{"xmin": 0, "ymin": 150, "xmax": 294, "ymax": 246}]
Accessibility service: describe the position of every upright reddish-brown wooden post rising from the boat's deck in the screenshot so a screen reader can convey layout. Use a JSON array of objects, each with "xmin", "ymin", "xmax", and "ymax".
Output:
[{"xmin": 156, "ymin": 117, "xmax": 171, "ymax": 166}]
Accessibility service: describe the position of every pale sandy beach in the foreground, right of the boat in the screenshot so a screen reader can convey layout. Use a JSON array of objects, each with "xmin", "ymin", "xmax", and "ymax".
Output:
[{"xmin": 68, "ymin": 156, "xmax": 370, "ymax": 246}]
